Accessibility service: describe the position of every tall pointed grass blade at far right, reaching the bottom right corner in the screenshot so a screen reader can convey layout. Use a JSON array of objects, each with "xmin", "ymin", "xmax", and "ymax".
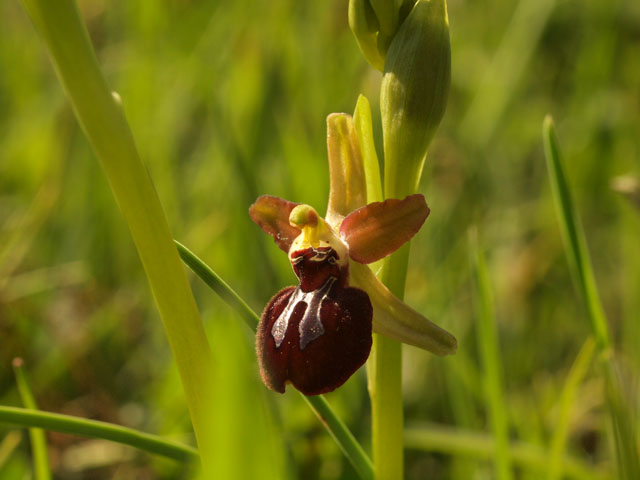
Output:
[{"xmin": 542, "ymin": 116, "xmax": 640, "ymax": 480}]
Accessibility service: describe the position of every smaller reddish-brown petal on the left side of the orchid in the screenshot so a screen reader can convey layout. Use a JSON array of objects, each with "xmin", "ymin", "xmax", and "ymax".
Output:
[{"xmin": 249, "ymin": 195, "xmax": 300, "ymax": 253}]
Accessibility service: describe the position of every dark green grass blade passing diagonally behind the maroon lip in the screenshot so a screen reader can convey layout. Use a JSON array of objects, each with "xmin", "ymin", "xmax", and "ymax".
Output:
[{"xmin": 175, "ymin": 241, "xmax": 373, "ymax": 480}]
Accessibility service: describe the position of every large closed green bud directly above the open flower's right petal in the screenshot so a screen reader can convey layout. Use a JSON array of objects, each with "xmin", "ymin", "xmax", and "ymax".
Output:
[{"xmin": 380, "ymin": 0, "xmax": 451, "ymax": 197}]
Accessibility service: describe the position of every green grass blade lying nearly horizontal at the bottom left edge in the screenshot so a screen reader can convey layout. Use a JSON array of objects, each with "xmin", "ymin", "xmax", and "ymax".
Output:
[{"xmin": 0, "ymin": 406, "xmax": 198, "ymax": 462}]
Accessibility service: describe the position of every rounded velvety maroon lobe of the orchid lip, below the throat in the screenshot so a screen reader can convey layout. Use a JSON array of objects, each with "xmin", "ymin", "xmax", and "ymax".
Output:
[{"xmin": 256, "ymin": 284, "xmax": 373, "ymax": 395}]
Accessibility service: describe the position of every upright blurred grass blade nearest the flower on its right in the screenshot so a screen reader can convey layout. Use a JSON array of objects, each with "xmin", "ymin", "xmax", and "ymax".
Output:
[{"xmin": 469, "ymin": 231, "xmax": 513, "ymax": 480}]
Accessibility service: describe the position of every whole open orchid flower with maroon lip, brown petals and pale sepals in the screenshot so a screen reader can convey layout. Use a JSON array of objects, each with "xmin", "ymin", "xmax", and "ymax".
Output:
[{"xmin": 249, "ymin": 114, "xmax": 456, "ymax": 395}]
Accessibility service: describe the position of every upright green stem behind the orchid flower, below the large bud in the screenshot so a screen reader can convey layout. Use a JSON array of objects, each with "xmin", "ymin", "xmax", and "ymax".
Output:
[{"xmin": 368, "ymin": 244, "xmax": 409, "ymax": 480}]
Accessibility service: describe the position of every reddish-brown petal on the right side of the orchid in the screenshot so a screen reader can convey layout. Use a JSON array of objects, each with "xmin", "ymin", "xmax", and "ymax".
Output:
[{"xmin": 340, "ymin": 194, "xmax": 429, "ymax": 263}]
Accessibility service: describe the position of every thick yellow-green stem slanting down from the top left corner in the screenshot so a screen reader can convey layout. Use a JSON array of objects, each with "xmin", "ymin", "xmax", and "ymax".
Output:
[{"xmin": 22, "ymin": 0, "xmax": 215, "ymax": 474}]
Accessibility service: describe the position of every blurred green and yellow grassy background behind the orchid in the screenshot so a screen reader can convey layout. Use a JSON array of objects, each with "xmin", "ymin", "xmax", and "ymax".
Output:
[{"xmin": 0, "ymin": 0, "xmax": 640, "ymax": 479}]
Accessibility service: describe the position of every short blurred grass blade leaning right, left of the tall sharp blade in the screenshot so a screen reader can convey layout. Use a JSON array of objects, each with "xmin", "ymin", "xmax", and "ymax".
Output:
[{"xmin": 547, "ymin": 337, "xmax": 596, "ymax": 480}]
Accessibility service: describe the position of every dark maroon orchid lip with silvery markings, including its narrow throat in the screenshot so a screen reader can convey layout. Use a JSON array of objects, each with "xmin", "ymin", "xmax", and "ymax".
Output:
[{"xmin": 257, "ymin": 247, "xmax": 373, "ymax": 395}]
